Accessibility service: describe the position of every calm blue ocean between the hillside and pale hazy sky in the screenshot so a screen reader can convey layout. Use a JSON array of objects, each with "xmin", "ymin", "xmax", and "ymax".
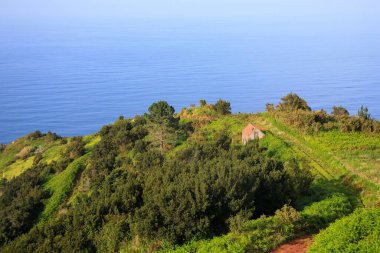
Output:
[{"xmin": 0, "ymin": 21, "xmax": 380, "ymax": 143}]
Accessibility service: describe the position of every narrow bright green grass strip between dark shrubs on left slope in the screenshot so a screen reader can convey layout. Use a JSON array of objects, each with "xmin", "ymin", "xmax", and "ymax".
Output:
[{"xmin": 40, "ymin": 154, "xmax": 90, "ymax": 223}]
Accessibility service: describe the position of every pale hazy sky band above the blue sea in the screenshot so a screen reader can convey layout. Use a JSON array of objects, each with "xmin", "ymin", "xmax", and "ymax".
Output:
[{"xmin": 0, "ymin": 0, "xmax": 380, "ymax": 32}]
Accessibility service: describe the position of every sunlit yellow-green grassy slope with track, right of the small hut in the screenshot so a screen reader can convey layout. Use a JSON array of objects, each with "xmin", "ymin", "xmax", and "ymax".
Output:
[{"xmin": 264, "ymin": 116, "xmax": 380, "ymax": 206}]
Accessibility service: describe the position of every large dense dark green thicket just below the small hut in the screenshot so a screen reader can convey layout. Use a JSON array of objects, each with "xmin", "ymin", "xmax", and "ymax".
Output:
[{"xmin": 133, "ymin": 143, "xmax": 312, "ymax": 242}]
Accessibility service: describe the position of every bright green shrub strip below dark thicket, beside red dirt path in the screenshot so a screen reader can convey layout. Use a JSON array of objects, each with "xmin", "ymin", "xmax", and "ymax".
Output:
[{"xmin": 162, "ymin": 191, "xmax": 356, "ymax": 253}]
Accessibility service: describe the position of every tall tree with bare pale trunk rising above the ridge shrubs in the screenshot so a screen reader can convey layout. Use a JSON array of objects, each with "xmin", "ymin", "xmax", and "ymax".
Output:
[{"xmin": 147, "ymin": 101, "xmax": 178, "ymax": 154}]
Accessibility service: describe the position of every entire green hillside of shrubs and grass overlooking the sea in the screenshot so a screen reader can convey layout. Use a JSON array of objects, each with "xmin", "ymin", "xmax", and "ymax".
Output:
[{"xmin": 0, "ymin": 93, "xmax": 380, "ymax": 252}]
